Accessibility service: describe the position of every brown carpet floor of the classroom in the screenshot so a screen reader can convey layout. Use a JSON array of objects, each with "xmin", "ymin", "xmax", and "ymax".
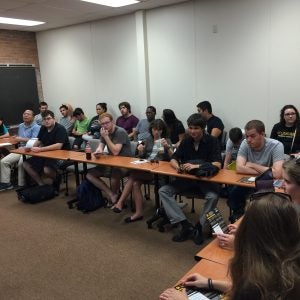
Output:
[{"xmin": 0, "ymin": 179, "xmax": 227, "ymax": 300}]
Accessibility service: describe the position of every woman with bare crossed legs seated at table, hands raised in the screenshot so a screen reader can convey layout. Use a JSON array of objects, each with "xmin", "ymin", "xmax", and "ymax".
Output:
[{"xmin": 113, "ymin": 119, "xmax": 173, "ymax": 223}]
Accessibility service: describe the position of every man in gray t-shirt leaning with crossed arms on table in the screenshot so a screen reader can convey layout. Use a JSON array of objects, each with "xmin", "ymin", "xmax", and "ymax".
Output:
[{"xmin": 228, "ymin": 120, "xmax": 284, "ymax": 222}]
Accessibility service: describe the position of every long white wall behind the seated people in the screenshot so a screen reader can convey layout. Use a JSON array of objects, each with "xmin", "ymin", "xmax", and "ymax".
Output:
[{"xmin": 37, "ymin": 0, "xmax": 300, "ymax": 133}]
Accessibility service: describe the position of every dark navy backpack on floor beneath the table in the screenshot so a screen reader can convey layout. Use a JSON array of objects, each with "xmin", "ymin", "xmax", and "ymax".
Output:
[{"xmin": 76, "ymin": 180, "xmax": 107, "ymax": 213}]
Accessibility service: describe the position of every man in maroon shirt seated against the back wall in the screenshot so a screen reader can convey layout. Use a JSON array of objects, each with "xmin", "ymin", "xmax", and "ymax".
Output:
[{"xmin": 116, "ymin": 102, "xmax": 139, "ymax": 140}]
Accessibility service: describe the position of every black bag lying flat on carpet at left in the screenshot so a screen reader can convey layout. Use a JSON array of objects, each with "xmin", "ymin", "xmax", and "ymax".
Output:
[{"xmin": 16, "ymin": 184, "xmax": 56, "ymax": 204}]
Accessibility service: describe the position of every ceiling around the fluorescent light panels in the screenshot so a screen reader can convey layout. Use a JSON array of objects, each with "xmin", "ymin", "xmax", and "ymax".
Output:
[{"xmin": 0, "ymin": 0, "xmax": 187, "ymax": 31}]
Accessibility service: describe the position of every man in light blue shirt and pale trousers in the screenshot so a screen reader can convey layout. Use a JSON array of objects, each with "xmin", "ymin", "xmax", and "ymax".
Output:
[{"xmin": 0, "ymin": 109, "xmax": 40, "ymax": 191}]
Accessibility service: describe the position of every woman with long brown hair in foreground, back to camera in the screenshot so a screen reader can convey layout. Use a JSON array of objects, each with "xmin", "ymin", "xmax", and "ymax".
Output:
[{"xmin": 159, "ymin": 193, "xmax": 300, "ymax": 300}]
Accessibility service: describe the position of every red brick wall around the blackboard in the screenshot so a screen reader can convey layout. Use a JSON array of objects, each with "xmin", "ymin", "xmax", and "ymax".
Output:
[{"xmin": 0, "ymin": 29, "xmax": 43, "ymax": 100}]
